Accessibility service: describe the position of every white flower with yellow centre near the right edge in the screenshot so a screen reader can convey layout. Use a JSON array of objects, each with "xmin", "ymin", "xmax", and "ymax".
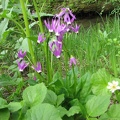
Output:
[{"xmin": 107, "ymin": 81, "xmax": 120, "ymax": 93}]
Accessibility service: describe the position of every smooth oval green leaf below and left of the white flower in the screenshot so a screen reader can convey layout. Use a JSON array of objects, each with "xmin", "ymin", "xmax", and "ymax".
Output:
[{"xmin": 86, "ymin": 95, "xmax": 110, "ymax": 117}]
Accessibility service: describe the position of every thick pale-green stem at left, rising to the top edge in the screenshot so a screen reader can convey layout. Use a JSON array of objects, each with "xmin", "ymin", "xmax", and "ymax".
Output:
[{"xmin": 20, "ymin": 0, "xmax": 36, "ymax": 64}]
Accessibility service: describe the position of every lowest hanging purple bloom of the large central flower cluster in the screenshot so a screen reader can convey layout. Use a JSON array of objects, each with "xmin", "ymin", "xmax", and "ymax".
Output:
[{"xmin": 49, "ymin": 40, "xmax": 62, "ymax": 58}]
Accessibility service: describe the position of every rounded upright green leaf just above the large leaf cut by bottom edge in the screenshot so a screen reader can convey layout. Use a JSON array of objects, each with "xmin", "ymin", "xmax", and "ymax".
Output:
[{"xmin": 22, "ymin": 83, "xmax": 47, "ymax": 106}]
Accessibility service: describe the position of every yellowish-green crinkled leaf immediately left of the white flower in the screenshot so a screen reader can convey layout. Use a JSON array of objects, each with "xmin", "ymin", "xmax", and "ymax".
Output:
[{"xmin": 91, "ymin": 69, "xmax": 113, "ymax": 95}]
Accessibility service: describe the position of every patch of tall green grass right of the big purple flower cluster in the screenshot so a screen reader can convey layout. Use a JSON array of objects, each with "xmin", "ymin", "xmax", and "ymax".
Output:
[{"xmin": 60, "ymin": 17, "xmax": 120, "ymax": 77}]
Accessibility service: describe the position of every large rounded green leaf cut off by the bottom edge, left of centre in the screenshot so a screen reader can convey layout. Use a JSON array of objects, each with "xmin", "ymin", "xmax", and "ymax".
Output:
[{"xmin": 24, "ymin": 103, "xmax": 62, "ymax": 120}]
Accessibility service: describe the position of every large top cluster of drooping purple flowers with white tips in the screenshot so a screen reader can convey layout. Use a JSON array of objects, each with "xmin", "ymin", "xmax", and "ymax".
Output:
[{"xmin": 44, "ymin": 8, "xmax": 80, "ymax": 58}]
